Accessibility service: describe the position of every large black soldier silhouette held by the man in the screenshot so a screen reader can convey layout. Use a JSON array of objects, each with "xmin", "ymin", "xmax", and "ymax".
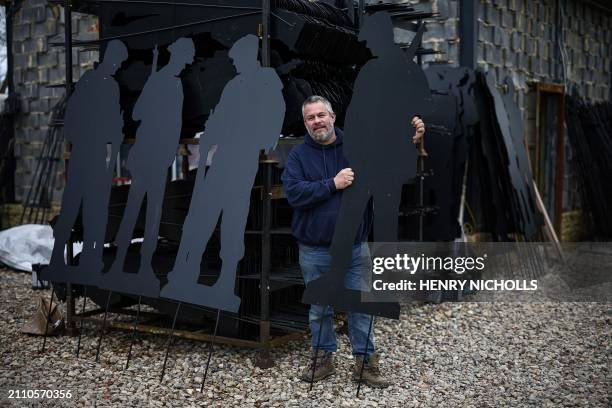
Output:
[{"xmin": 302, "ymin": 12, "xmax": 430, "ymax": 317}]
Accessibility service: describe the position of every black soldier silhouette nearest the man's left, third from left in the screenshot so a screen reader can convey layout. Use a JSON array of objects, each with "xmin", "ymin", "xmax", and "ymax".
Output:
[{"xmin": 160, "ymin": 35, "xmax": 285, "ymax": 312}]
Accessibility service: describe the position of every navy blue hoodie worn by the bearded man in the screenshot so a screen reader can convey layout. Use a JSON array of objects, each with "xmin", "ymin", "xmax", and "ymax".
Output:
[{"xmin": 282, "ymin": 128, "xmax": 372, "ymax": 246}]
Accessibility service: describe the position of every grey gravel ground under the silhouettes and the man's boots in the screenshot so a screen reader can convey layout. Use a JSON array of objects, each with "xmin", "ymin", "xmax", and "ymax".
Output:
[{"xmin": 0, "ymin": 269, "xmax": 612, "ymax": 407}]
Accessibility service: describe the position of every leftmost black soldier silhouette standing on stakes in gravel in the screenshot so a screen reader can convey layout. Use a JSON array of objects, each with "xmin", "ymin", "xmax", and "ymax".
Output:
[{"xmin": 44, "ymin": 40, "xmax": 128, "ymax": 284}]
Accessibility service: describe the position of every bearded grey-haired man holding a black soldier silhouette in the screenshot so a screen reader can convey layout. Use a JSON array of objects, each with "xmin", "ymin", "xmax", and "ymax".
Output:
[{"xmin": 282, "ymin": 96, "xmax": 425, "ymax": 387}]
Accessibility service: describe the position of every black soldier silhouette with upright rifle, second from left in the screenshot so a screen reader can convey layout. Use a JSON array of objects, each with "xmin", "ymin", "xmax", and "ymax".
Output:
[{"xmin": 98, "ymin": 38, "xmax": 195, "ymax": 297}]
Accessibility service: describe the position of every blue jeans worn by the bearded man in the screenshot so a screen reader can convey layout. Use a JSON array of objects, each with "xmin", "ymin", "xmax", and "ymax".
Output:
[{"xmin": 300, "ymin": 243, "xmax": 374, "ymax": 361}]
